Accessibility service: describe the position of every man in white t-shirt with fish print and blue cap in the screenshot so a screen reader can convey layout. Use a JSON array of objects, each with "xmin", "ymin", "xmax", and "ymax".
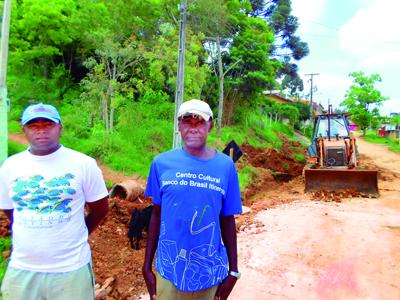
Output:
[{"xmin": 0, "ymin": 103, "xmax": 108, "ymax": 300}]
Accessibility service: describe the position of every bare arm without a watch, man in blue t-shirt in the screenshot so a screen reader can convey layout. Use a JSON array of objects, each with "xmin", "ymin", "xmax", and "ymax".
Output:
[{"xmin": 142, "ymin": 204, "xmax": 161, "ymax": 299}]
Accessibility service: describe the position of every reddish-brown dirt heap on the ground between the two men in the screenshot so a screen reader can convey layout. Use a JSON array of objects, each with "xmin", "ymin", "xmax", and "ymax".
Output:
[{"xmin": 89, "ymin": 195, "xmax": 151, "ymax": 300}]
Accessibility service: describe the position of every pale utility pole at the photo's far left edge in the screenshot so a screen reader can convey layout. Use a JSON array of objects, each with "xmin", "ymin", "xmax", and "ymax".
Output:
[{"xmin": 0, "ymin": 0, "xmax": 11, "ymax": 165}]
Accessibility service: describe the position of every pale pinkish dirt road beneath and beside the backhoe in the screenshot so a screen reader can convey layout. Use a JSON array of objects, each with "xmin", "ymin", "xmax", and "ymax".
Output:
[{"xmin": 231, "ymin": 139, "xmax": 400, "ymax": 300}]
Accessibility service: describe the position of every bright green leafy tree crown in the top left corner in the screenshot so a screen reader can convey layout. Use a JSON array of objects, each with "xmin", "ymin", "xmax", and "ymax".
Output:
[{"xmin": 10, "ymin": 0, "xmax": 76, "ymax": 77}]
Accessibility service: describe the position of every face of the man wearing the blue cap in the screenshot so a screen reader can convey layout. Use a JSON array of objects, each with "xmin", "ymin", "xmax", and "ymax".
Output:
[{"xmin": 23, "ymin": 118, "xmax": 62, "ymax": 155}]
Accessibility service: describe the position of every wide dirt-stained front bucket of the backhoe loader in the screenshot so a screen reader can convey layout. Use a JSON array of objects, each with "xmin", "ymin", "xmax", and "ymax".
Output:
[{"xmin": 304, "ymin": 168, "xmax": 379, "ymax": 195}]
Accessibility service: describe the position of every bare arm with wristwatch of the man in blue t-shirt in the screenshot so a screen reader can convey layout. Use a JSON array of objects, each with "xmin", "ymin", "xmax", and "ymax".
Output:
[{"xmin": 215, "ymin": 215, "xmax": 238, "ymax": 300}]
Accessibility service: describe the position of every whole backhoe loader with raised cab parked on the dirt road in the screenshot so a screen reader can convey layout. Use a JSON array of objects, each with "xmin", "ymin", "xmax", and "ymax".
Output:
[{"xmin": 304, "ymin": 106, "xmax": 378, "ymax": 196}]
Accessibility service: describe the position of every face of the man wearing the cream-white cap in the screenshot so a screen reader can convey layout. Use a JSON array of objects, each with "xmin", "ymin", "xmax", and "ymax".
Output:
[{"xmin": 178, "ymin": 115, "xmax": 213, "ymax": 149}]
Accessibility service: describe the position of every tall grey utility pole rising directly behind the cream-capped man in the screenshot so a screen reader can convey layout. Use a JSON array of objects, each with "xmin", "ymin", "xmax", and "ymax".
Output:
[{"xmin": 172, "ymin": 0, "xmax": 187, "ymax": 148}]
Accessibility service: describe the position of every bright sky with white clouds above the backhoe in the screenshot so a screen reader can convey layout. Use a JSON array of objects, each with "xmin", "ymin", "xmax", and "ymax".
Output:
[{"xmin": 292, "ymin": 0, "xmax": 400, "ymax": 115}]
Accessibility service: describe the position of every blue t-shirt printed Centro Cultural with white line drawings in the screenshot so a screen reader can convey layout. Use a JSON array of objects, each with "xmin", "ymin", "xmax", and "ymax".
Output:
[{"xmin": 145, "ymin": 148, "xmax": 242, "ymax": 292}]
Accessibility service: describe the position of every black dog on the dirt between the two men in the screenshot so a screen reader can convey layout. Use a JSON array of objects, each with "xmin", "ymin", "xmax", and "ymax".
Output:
[{"xmin": 128, "ymin": 205, "xmax": 153, "ymax": 250}]
